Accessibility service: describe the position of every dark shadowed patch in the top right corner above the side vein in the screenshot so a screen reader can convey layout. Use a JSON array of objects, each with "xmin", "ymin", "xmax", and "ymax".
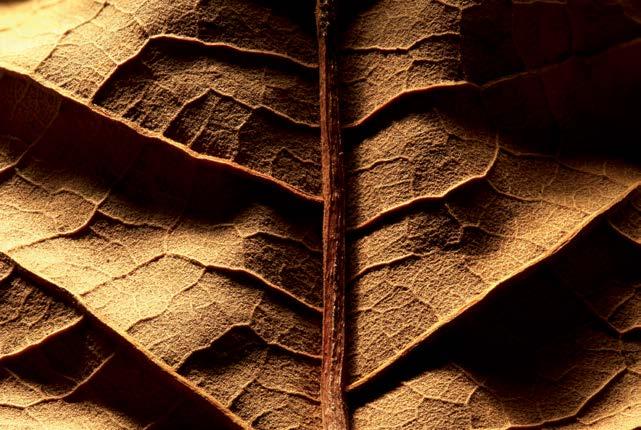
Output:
[{"xmin": 461, "ymin": 0, "xmax": 641, "ymax": 83}]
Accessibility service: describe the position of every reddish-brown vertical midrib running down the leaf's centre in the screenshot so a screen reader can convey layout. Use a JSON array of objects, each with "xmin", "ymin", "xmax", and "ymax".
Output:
[{"xmin": 316, "ymin": 0, "xmax": 348, "ymax": 430}]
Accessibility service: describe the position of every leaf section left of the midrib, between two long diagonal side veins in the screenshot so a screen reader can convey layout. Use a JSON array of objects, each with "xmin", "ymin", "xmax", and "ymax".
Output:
[{"xmin": 0, "ymin": 75, "xmax": 320, "ymax": 426}]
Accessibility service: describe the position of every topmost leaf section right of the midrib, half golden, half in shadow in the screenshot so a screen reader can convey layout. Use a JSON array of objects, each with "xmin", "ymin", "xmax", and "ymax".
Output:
[{"xmin": 340, "ymin": 0, "xmax": 639, "ymax": 123}]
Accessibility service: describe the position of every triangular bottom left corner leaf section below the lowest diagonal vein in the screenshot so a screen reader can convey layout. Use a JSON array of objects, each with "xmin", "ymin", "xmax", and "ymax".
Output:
[{"xmin": 0, "ymin": 257, "xmax": 245, "ymax": 429}]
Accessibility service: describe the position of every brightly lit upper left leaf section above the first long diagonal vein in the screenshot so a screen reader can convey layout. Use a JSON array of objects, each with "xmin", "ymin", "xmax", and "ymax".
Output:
[{"xmin": 0, "ymin": 0, "xmax": 320, "ymax": 198}]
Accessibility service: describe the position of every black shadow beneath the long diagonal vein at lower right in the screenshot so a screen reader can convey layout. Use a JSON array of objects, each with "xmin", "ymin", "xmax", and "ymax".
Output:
[{"xmin": 350, "ymin": 222, "xmax": 641, "ymax": 424}]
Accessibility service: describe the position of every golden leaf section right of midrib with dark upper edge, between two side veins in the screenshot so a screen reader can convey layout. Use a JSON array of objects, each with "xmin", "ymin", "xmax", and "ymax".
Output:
[{"xmin": 344, "ymin": 3, "xmax": 641, "ymax": 387}]
